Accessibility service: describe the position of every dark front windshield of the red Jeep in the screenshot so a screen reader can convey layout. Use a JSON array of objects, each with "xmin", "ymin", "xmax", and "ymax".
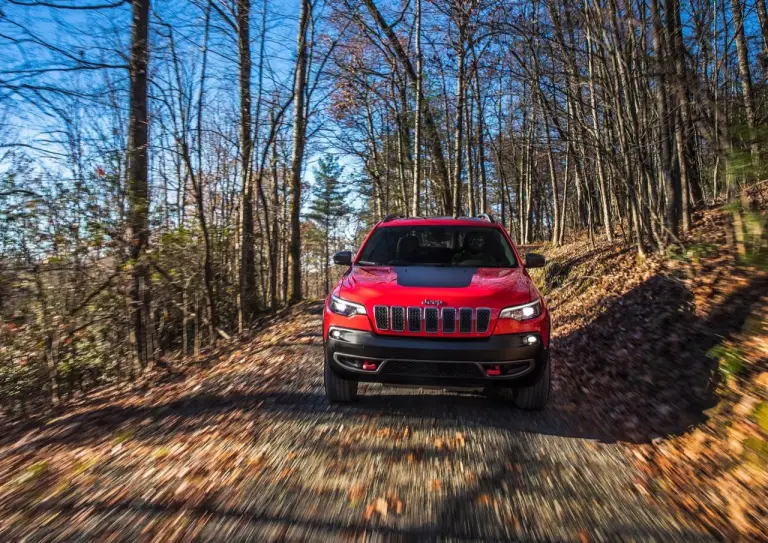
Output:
[{"xmin": 357, "ymin": 226, "xmax": 517, "ymax": 268}]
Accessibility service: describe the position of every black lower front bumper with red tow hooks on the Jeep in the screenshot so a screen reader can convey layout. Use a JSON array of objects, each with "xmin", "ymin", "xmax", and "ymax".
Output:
[{"xmin": 325, "ymin": 327, "xmax": 549, "ymax": 388}]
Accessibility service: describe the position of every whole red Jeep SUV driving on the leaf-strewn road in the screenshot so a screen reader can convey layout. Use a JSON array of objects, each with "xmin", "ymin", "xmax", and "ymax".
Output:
[{"xmin": 323, "ymin": 214, "xmax": 551, "ymax": 409}]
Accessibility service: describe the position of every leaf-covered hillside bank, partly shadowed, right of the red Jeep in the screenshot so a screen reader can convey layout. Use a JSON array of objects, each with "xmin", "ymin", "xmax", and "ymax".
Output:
[{"xmin": 538, "ymin": 210, "xmax": 768, "ymax": 539}]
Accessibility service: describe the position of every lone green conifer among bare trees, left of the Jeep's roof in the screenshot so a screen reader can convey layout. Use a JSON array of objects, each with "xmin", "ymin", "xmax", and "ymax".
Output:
[{"xmin": 307, "ymin": 155, "xmax": 350, "ymax": 292}]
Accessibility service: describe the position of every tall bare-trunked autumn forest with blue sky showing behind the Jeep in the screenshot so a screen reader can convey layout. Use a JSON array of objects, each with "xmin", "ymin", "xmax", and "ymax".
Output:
[{"xmin": 0, "ymin": 0, "xmax": 768, "ymax": 413}]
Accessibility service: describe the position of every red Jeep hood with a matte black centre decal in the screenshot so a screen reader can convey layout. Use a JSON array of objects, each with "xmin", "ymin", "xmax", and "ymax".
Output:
[{"xmin": 338, "ymin": 266, "xmax": 538, "ymax": 311}]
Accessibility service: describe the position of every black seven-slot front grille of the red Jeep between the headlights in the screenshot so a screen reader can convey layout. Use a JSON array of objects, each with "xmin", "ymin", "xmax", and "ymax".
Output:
[{"xmin": 373, "ymin": 305, "xmax": 491, "ymax": 334}]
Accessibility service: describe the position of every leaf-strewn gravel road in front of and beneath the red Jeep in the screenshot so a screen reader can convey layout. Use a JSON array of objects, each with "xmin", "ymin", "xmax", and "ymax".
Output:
[{"xmin": 0, "ymin": 306, "xmax": 708, "ymax": 542}]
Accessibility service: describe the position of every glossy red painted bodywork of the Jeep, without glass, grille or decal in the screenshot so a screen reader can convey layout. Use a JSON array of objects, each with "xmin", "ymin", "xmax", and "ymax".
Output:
[{"xmin": 323, "ymin": 218, "xmax": 549, "ymax": 348}]
